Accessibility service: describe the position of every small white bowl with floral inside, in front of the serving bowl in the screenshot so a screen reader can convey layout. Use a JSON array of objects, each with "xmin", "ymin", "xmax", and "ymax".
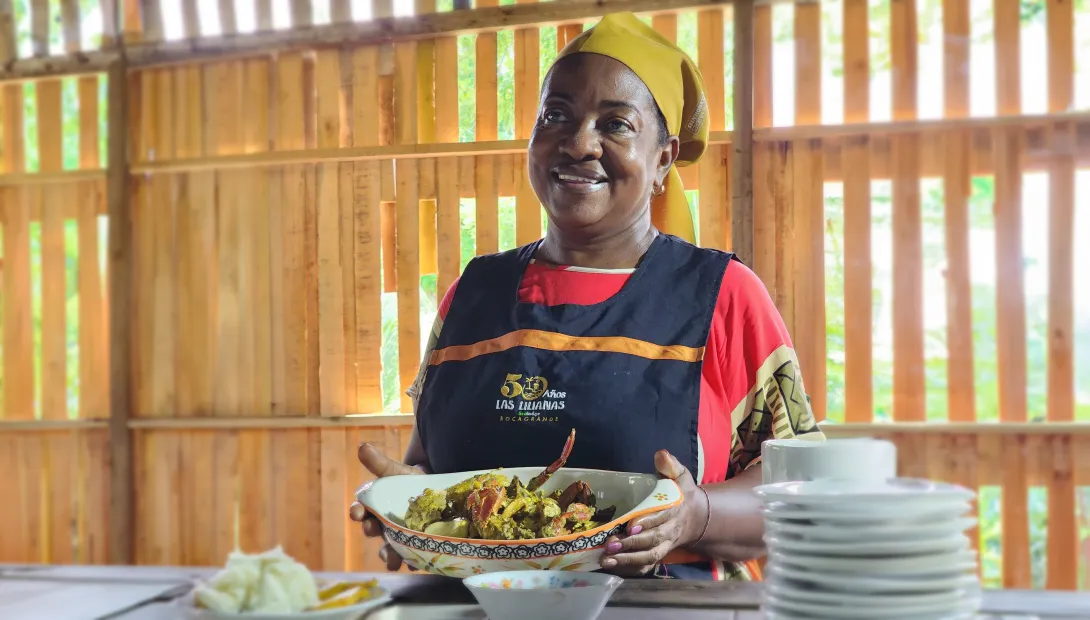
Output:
[{"xmin": 462, "ymin": 571, "xmax": 625, "ymax": 620}]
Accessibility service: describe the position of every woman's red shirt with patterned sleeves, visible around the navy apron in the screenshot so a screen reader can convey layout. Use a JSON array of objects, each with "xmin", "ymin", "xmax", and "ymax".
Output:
[{"xmin": 425, "ymin": 256, "xmax": 822, "ymax": 484}]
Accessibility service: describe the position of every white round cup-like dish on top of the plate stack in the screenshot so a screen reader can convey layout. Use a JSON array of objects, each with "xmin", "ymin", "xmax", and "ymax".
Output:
[{"xmin": 761, "ymin": 437, "xmax": 897, "ymax": 484}]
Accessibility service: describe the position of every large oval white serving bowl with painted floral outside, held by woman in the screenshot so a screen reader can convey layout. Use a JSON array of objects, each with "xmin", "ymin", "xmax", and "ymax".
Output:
[{"xmin": 355, "ymin": 467, "xmax": 682, "ymax": 579}]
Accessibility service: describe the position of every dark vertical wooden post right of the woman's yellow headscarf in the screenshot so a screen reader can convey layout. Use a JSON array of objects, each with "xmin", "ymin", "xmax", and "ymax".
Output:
[{"xmin": 730, "ymin": 0, "xmax": 753, "ymax": 265}]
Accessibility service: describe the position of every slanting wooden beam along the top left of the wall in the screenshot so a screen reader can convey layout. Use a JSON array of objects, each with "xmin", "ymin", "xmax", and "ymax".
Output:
[{"xmin": 0, "ymin": 0, "xmax": 758, "ymax": 82}]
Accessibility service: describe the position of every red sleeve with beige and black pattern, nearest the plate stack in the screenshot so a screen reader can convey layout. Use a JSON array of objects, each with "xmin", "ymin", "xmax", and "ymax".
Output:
[{"xmin": 724, "ymin": 264, "xmax": 825, "ymax": 478}]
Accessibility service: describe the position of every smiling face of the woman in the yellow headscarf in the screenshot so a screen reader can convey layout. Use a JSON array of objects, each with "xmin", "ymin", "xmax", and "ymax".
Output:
[{"xmin": 529, "ymin": 53, "xmax": 678, "ymax": 235}]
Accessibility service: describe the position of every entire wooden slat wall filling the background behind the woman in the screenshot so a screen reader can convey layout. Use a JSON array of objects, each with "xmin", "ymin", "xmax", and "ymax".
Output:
[{"xmin": 0, "ymin": 0, "xmax": 1090, "ymax": 588}]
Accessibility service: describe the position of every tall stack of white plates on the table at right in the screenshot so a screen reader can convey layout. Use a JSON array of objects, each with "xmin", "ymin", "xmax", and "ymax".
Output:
[{"xmin": 756, "ymin": 478, "xmax": 981, "ymax": 620}]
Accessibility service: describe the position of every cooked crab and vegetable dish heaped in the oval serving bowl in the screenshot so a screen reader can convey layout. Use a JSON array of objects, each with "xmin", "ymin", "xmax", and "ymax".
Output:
[{"xmin": 404, "ymin": 430, "xmax": 617, "ymax": 540}]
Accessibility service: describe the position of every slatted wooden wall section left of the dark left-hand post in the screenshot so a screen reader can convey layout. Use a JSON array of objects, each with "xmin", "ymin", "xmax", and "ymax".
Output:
[{"xmin": 0, "ymin": 65, "xmax": 110, "ymax": 563}]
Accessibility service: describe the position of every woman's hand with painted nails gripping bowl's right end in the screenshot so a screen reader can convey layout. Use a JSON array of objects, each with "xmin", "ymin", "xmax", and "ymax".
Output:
[{"xmin": 602, "ymin": 450, "xmax": 707, "ymax": 576}]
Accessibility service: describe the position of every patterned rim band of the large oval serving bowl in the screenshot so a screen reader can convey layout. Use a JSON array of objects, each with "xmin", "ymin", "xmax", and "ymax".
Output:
[{"xmin": 355, "ymin": 467, "xmax": 685, "ymax": 546}]
